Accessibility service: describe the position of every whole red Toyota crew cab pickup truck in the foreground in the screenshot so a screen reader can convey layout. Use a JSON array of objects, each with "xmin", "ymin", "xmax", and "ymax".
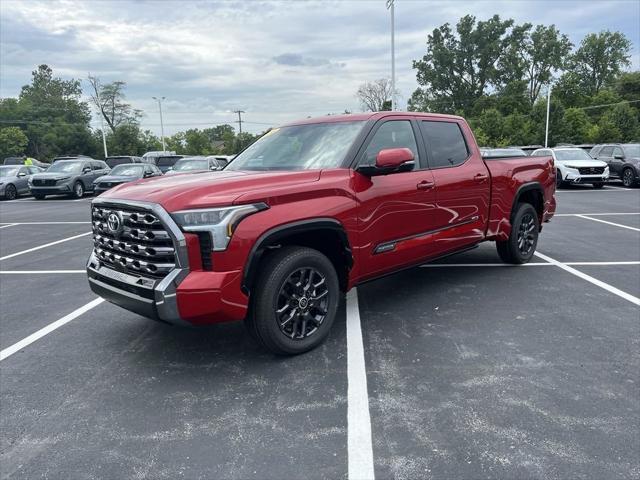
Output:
[{"xmin": 87, "ymin": 112, "xmax": 556, "ymax": 354}]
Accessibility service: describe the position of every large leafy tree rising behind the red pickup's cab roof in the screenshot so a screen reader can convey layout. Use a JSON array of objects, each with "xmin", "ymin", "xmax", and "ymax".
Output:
[{"xmin": 410, "ymin": 15, "xmax": 513, "ymax": 112}]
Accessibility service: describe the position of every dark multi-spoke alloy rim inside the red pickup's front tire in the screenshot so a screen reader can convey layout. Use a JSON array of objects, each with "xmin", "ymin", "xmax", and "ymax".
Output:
[{"xmin": 275, "ymin": 268, "xmax": 329, "ymax": 340}]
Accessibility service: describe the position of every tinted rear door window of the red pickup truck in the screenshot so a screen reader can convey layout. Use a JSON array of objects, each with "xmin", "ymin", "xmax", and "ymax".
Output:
[{"xmin": 420, "ymin": 121, "xmax": 469, "ymax": 168}]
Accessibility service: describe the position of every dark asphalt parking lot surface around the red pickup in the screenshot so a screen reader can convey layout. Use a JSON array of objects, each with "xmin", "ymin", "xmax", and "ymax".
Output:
[{"xmin": 0, "ymin": 186, "xmax": 640, "ymax": 479}]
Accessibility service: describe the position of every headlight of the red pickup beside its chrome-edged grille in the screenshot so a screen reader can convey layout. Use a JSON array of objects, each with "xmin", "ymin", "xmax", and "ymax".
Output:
[{"xmin": 171, "ymin": 203, "xmax": 269, "ymax": 252}]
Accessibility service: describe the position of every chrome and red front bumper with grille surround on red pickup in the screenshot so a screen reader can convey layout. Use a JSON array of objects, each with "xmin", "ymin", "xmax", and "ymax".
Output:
[{"xmin": 87, "ymin": 198, "xmax": 248, "ymax": 326}]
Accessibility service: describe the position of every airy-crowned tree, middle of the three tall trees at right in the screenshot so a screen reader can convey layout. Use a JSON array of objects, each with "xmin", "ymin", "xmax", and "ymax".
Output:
[{"xmin": 501, "ymin": 23, "xmax": 573, "ymax": 105}]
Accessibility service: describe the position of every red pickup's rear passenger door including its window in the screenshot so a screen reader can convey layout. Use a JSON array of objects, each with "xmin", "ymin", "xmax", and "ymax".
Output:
[{"xmin": 419, "ymin": 118, "xmax": 491, "ymax": 253}]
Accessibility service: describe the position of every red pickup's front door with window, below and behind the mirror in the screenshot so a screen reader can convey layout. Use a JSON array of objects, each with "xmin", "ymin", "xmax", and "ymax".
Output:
[{"xmin": 353, "ymin": 116, "xmax": 436, "ymax": 278}]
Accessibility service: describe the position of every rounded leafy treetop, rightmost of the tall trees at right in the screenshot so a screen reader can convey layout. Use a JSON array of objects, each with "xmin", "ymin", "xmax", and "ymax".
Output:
[{"xmin": 570, "ymin": 30, "xmax": 631, "ymax": 95}]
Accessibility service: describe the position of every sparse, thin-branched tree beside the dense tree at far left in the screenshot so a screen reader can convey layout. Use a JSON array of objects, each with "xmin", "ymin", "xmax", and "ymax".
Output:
[{"xmin": 88, "ymin": 74, "xmax": 142, "ymax": 133}]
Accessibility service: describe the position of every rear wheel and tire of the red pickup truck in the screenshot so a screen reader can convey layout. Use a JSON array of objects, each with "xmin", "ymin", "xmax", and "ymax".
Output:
[{"xmin": 496, "ymin": 203, "xmax": 540, "ymax": 265}]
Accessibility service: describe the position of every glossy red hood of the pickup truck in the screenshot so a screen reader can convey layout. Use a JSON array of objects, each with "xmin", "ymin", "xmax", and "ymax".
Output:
[{"xmin": 100, "ymin": 170, "xmax": 320, "ymax": 212}]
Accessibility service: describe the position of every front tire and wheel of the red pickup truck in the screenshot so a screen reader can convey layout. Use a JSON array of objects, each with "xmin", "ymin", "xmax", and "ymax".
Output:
[{"xmin": 245, "ymin": 247, "xmax": 340, "ymax": 355}]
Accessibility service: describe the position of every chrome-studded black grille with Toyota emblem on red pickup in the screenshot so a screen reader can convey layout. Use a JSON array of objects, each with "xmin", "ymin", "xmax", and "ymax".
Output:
[{"xmin": 92, "ymin": 206, "xmax": 176, "ymax": 278}]
